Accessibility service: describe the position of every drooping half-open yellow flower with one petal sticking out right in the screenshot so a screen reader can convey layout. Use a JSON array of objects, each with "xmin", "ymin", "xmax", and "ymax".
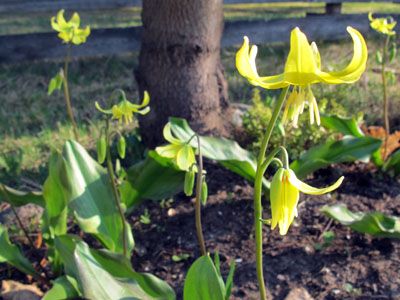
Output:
[{"xmin": 270, "ymin": 168, "xmax": 344, "ymax": 235}]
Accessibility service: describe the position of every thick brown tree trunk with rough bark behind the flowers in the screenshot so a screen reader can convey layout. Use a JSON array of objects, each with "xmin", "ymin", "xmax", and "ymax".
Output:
[{"xmin": 135, "ymin": 0, "xmax": 228, "ymax": 147}]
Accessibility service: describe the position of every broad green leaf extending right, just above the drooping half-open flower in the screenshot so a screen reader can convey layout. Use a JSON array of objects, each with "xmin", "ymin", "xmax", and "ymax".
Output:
[{"xmin": 290, "ymin": 136, "xmax": 382, "ymax": 178}]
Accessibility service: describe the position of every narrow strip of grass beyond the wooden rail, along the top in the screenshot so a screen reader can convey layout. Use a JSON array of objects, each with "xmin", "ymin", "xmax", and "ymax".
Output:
[{"xmin": 0, "ymin": 2, "xmax": 400, "ymax": 35}]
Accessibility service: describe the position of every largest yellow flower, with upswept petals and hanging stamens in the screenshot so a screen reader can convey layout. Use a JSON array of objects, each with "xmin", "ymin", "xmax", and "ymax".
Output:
[{"xmin": 236, "ymin": 27, "xmax": 368, "ymax": 127}]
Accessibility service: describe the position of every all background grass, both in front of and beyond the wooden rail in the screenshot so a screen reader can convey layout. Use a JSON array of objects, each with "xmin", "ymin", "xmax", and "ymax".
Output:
[{"xmin": 0, "ymin": 3, "xmax": 400, "ymax": 183}]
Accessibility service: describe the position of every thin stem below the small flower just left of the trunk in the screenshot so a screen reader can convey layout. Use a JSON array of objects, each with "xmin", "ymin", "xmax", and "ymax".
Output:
[{"xmin": 105, "ymin": 119, "xmax": 128, "ymax": 256}]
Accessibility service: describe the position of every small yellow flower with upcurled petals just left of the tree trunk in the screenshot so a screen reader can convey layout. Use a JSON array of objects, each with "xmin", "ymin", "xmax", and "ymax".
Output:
[{"xmin": 95, "ymin": 91, "xmax": 150, "ymax": 124}]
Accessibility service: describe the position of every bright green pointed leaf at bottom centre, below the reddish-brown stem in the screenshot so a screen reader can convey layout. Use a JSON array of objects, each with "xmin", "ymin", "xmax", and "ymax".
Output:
[{"xmin": 183, "ymin": 255, "xmax": 225, "ymax": 300}]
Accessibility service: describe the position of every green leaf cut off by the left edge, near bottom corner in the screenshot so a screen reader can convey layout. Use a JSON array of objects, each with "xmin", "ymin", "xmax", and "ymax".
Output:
[{"xmin": 0, "ymin": 224, "xmax": 39, "ymax": 277}]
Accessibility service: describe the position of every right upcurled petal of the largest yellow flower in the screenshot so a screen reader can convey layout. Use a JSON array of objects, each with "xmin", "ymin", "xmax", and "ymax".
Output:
[{"xmin": 319, "ymin": 26, "xmax": 368, "ymax": 84}]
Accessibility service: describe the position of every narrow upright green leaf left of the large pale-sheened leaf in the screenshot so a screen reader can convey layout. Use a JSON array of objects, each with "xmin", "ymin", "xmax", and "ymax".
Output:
[{"xmin": 43, "ymin": 153, "xmax": 68, "ymax": 239}]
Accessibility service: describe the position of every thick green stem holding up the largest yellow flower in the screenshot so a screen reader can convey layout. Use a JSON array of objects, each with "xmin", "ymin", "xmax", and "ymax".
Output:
[{"xmin": 254, "ymin": 87, "xmax": 289, "ymax": 300}]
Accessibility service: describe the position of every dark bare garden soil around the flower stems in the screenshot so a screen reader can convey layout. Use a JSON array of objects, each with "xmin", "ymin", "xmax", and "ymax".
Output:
[{"xmin": 0, "ymin": 164, "xmax": 400, "ymax": 299}]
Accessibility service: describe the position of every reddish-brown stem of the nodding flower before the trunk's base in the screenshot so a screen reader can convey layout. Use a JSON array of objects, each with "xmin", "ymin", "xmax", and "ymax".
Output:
[{"xmin": 195, "ymin": 135, "xmax": 207, "ymax": 255}]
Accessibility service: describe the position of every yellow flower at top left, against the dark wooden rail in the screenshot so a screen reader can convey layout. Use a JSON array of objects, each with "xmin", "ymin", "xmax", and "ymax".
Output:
[{"xmin": 51, "ymin": 9, "xmax": 90, "ymax": 45}]
